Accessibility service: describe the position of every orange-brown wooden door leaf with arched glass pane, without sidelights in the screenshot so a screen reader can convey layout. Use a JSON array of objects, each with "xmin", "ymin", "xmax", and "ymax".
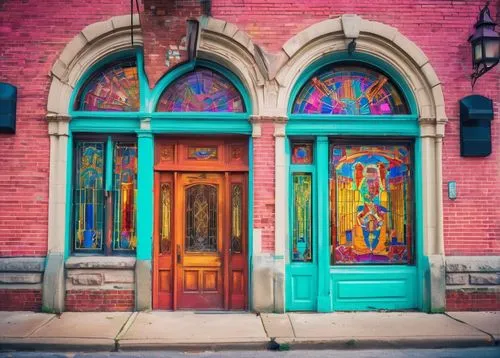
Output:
[{"xmin": 175, "ymin": 173, "xmax": 226, "ymax": 309}]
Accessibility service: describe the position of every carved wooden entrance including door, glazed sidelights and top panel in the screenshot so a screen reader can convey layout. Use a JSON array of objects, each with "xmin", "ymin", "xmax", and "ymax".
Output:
[{"xmin": 153, "ymin": 139, "xmax": 248, "ymax": 310}]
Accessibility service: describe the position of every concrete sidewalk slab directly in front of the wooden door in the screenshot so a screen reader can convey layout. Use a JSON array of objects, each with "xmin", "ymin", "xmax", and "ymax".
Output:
[{"xmin": 119, "ymin": 312, "xmax": 269, "ymax": 349}]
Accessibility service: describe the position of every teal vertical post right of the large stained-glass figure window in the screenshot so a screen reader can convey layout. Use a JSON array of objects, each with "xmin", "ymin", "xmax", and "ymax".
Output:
[{"xmin": 413, "ymin": 137, "xmax": 430, "ymax": 311}]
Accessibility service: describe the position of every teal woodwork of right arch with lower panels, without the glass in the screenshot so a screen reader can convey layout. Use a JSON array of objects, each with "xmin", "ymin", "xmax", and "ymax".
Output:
[{"xmin": 285, "ymin": 52, "xmax": 428, "ymax": 312}]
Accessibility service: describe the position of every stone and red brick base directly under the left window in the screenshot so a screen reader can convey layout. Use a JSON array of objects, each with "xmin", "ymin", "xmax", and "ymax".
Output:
[{"xmin": 65, "ymin": 257, "xmax": 136, "ymax": 312}]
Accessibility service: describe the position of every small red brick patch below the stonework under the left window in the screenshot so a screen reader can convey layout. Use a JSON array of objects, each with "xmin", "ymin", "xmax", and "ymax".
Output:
[{"xmin": 65, "ymin": 290, "xmax": 135, "ymax": 312}]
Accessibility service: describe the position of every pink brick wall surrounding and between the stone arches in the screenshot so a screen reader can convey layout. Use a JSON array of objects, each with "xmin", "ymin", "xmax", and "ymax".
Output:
[{"xmin": 0, "ymin": 0, "xmax": 500, "ymax": 256}]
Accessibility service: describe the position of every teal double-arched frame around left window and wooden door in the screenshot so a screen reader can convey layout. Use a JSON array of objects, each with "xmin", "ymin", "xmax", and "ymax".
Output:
[{"xmin": 65, "ymin": 48, "xmax": 253, "ymax": 304}]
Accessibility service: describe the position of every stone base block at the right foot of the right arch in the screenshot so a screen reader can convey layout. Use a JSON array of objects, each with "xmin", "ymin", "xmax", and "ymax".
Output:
[{"xmin": 429, "ymin": 255, "xmax": 446, "ymax": 313}]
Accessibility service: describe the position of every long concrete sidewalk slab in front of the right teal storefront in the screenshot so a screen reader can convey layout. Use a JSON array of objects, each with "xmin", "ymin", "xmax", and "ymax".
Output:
[{"xmin": 281, "ymin": 312, "xmax": 493, "ymax": 348}]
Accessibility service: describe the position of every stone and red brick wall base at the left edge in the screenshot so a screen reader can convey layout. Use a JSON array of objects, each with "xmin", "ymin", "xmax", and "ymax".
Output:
[{"xmin": 0, "ymin": 257, "xmax": 45, "ymax": 311}]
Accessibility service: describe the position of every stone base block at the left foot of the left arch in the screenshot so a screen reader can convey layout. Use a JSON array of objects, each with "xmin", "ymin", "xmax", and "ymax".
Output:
[{"xmin": 42, "ymin": 252, "xmax": 66, "ymax": 313}]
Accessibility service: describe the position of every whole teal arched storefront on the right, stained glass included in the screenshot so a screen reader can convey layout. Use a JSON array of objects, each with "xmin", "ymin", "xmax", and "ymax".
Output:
[{"xmin": 285, "ymin": 52, "xmax": 426, "ymax": 312}]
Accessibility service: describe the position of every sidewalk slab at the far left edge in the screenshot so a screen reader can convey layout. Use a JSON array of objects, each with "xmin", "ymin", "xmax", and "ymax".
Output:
[{"xmin": 0, "ymin": 312, "xmax": 55, "ymax": 338}]
